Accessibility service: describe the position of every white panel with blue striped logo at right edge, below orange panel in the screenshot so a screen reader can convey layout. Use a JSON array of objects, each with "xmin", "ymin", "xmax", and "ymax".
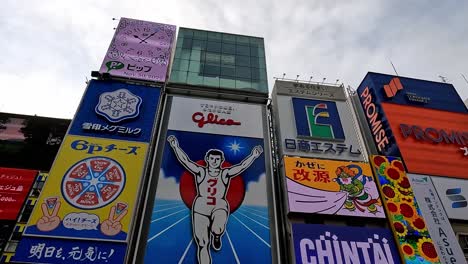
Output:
[{"xmin": 431, "ymin": 177, "xmax": 468, "ymax": 220}]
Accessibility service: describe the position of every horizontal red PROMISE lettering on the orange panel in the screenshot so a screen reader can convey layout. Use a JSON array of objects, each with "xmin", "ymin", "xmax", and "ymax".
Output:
[{"xmin": 400, "ymin": 124, "xmax": 468, "ymax": 146}]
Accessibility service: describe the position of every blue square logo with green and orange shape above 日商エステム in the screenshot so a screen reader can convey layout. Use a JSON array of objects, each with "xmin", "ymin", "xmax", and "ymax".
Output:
[{"xmin": 292, "ymin": 98, "xmax": 345, "ymax": 141}]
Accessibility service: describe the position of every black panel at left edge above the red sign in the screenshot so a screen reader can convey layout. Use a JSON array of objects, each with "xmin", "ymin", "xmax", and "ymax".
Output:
[{"xmin": 0, "ymin": 113, "xmax": 70, "ymax": 171}]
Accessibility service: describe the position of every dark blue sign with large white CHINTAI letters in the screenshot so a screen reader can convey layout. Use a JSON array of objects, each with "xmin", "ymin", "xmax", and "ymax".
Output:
[{"xmin": 292, "ymin": 224, "xmax": 401, "ymax": 264}]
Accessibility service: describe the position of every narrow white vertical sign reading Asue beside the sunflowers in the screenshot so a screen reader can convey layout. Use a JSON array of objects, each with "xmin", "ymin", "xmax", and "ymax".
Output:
[{"xmin": 408, "ymin": 174, "xmax": 466, "ymax": 264}]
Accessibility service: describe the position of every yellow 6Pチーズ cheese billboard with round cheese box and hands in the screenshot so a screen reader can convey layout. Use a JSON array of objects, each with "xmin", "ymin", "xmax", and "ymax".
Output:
[{"xmin": 24, "ymin": 135, "xmax": 147, "ymax": 242}]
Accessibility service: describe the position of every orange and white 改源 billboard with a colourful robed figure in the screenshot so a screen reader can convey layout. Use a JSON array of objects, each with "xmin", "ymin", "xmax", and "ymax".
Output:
[{"xmin": 284, "ymin": 156, "xmax": 385, "ymax": 218}]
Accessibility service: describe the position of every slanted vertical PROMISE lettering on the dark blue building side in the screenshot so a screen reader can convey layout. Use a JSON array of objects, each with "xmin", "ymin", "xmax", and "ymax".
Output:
[{"xmin": 360, "ymin": 87, "xmax": 389, "ymax": 152}]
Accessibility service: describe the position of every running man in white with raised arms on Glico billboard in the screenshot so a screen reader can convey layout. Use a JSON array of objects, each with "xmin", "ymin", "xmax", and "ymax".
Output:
[{"xmin": 167, "ymin": 136, "xmax": 263, "ymax": 264}]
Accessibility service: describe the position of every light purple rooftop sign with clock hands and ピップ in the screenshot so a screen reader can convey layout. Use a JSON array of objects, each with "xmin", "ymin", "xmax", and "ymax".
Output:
[{"xmin": 99, "ymin": 17, "xmax": 176, "ymax": 82}]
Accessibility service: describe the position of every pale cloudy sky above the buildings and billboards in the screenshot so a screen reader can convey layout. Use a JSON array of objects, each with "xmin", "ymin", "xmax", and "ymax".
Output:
[{"xmin": 0, "ymin": 0, "xmax": 468, "ymax": 118}]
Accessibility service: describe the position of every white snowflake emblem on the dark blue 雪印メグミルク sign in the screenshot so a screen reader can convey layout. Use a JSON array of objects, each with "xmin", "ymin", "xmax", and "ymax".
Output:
[{"xmin": 95, "ymin": 89, "xmax": 143, "ymax": 123}]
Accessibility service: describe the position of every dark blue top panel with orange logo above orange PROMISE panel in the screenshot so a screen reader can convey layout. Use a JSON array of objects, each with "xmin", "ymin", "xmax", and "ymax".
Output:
[{"xmin": 358, "ymin": 72, "xmax": 468, "ymax": 113}]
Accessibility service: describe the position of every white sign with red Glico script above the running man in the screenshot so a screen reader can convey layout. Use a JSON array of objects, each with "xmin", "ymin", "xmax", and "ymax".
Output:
[{"xmin": 169, "ymin": 97, "xmax": 263, "ymax": 138}]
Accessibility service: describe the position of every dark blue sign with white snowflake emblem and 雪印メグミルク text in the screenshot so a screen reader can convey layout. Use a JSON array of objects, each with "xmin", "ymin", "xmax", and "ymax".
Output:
[{"xmin": 69, "ymin": 80, "xmax": 161, "ymax": 142}]
